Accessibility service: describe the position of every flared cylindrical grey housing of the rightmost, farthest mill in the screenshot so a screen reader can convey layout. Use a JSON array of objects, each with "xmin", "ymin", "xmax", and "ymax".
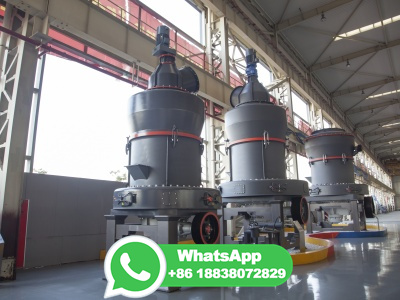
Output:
[{"xmin": 305, "ymin": 128, "xmax": 358, "ymax": 186}]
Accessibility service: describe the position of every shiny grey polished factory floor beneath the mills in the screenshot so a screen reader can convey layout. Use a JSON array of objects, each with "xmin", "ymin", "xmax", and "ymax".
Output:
[{"xmin": 0, "ymin": 212, "xmax": 400, "ymax": 300}]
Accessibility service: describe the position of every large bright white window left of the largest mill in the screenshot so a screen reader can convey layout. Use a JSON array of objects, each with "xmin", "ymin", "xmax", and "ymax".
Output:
[{"xmin": 34, "ymin": 55, "xmax": 140, "ymax": 180}]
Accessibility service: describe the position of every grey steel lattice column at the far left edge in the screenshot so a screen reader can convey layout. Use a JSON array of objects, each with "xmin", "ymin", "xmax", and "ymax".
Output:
[{"xmin": 0, "ymin": 4, "xmax": 38, "ymax": 279}]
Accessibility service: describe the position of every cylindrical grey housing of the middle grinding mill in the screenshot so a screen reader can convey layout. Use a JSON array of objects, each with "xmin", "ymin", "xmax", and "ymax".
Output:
[{"xmin": 225, "ymin": 103, "xmax": 287, "ymax": 181}]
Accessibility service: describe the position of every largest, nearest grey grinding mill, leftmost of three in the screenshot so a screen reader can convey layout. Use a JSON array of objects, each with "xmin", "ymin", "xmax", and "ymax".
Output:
[{"xmin": 106, "ymin": 26, "xmax": 220, "ymax": 250}]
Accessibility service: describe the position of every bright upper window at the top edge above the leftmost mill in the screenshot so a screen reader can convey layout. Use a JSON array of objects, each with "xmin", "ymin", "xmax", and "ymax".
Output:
[{"xmin": 140, "ymin": 0, "xmax": 204, "ymax": 44}]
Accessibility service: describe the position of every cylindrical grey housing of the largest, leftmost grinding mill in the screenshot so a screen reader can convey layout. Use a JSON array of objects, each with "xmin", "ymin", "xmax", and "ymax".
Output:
[{"xmin": 129, "ymin": 89, "xmax": 204, "ymax": 186}]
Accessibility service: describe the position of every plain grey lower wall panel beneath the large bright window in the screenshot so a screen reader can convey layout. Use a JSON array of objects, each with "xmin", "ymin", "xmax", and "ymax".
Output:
[{"xmin": 23, "ymin": 173, "xmax": 126, "ymax": 268}]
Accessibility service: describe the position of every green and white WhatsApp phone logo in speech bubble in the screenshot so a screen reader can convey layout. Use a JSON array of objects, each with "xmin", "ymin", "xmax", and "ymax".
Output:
[{"xmin": 104, "ymin": 235, "xmax": 167, "ymax": 298}]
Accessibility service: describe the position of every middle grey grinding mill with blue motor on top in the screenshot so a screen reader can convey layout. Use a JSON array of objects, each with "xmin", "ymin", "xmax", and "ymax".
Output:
[{"xmin": 219, "ymin": 49, "xmax": 308, "ymax": 248}]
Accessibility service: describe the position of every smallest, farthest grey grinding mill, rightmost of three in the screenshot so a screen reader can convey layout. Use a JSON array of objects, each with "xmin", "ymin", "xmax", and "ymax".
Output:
[{"xmin": 305, "ymin": 128, "xmax": 374, "ymax": 233}]
